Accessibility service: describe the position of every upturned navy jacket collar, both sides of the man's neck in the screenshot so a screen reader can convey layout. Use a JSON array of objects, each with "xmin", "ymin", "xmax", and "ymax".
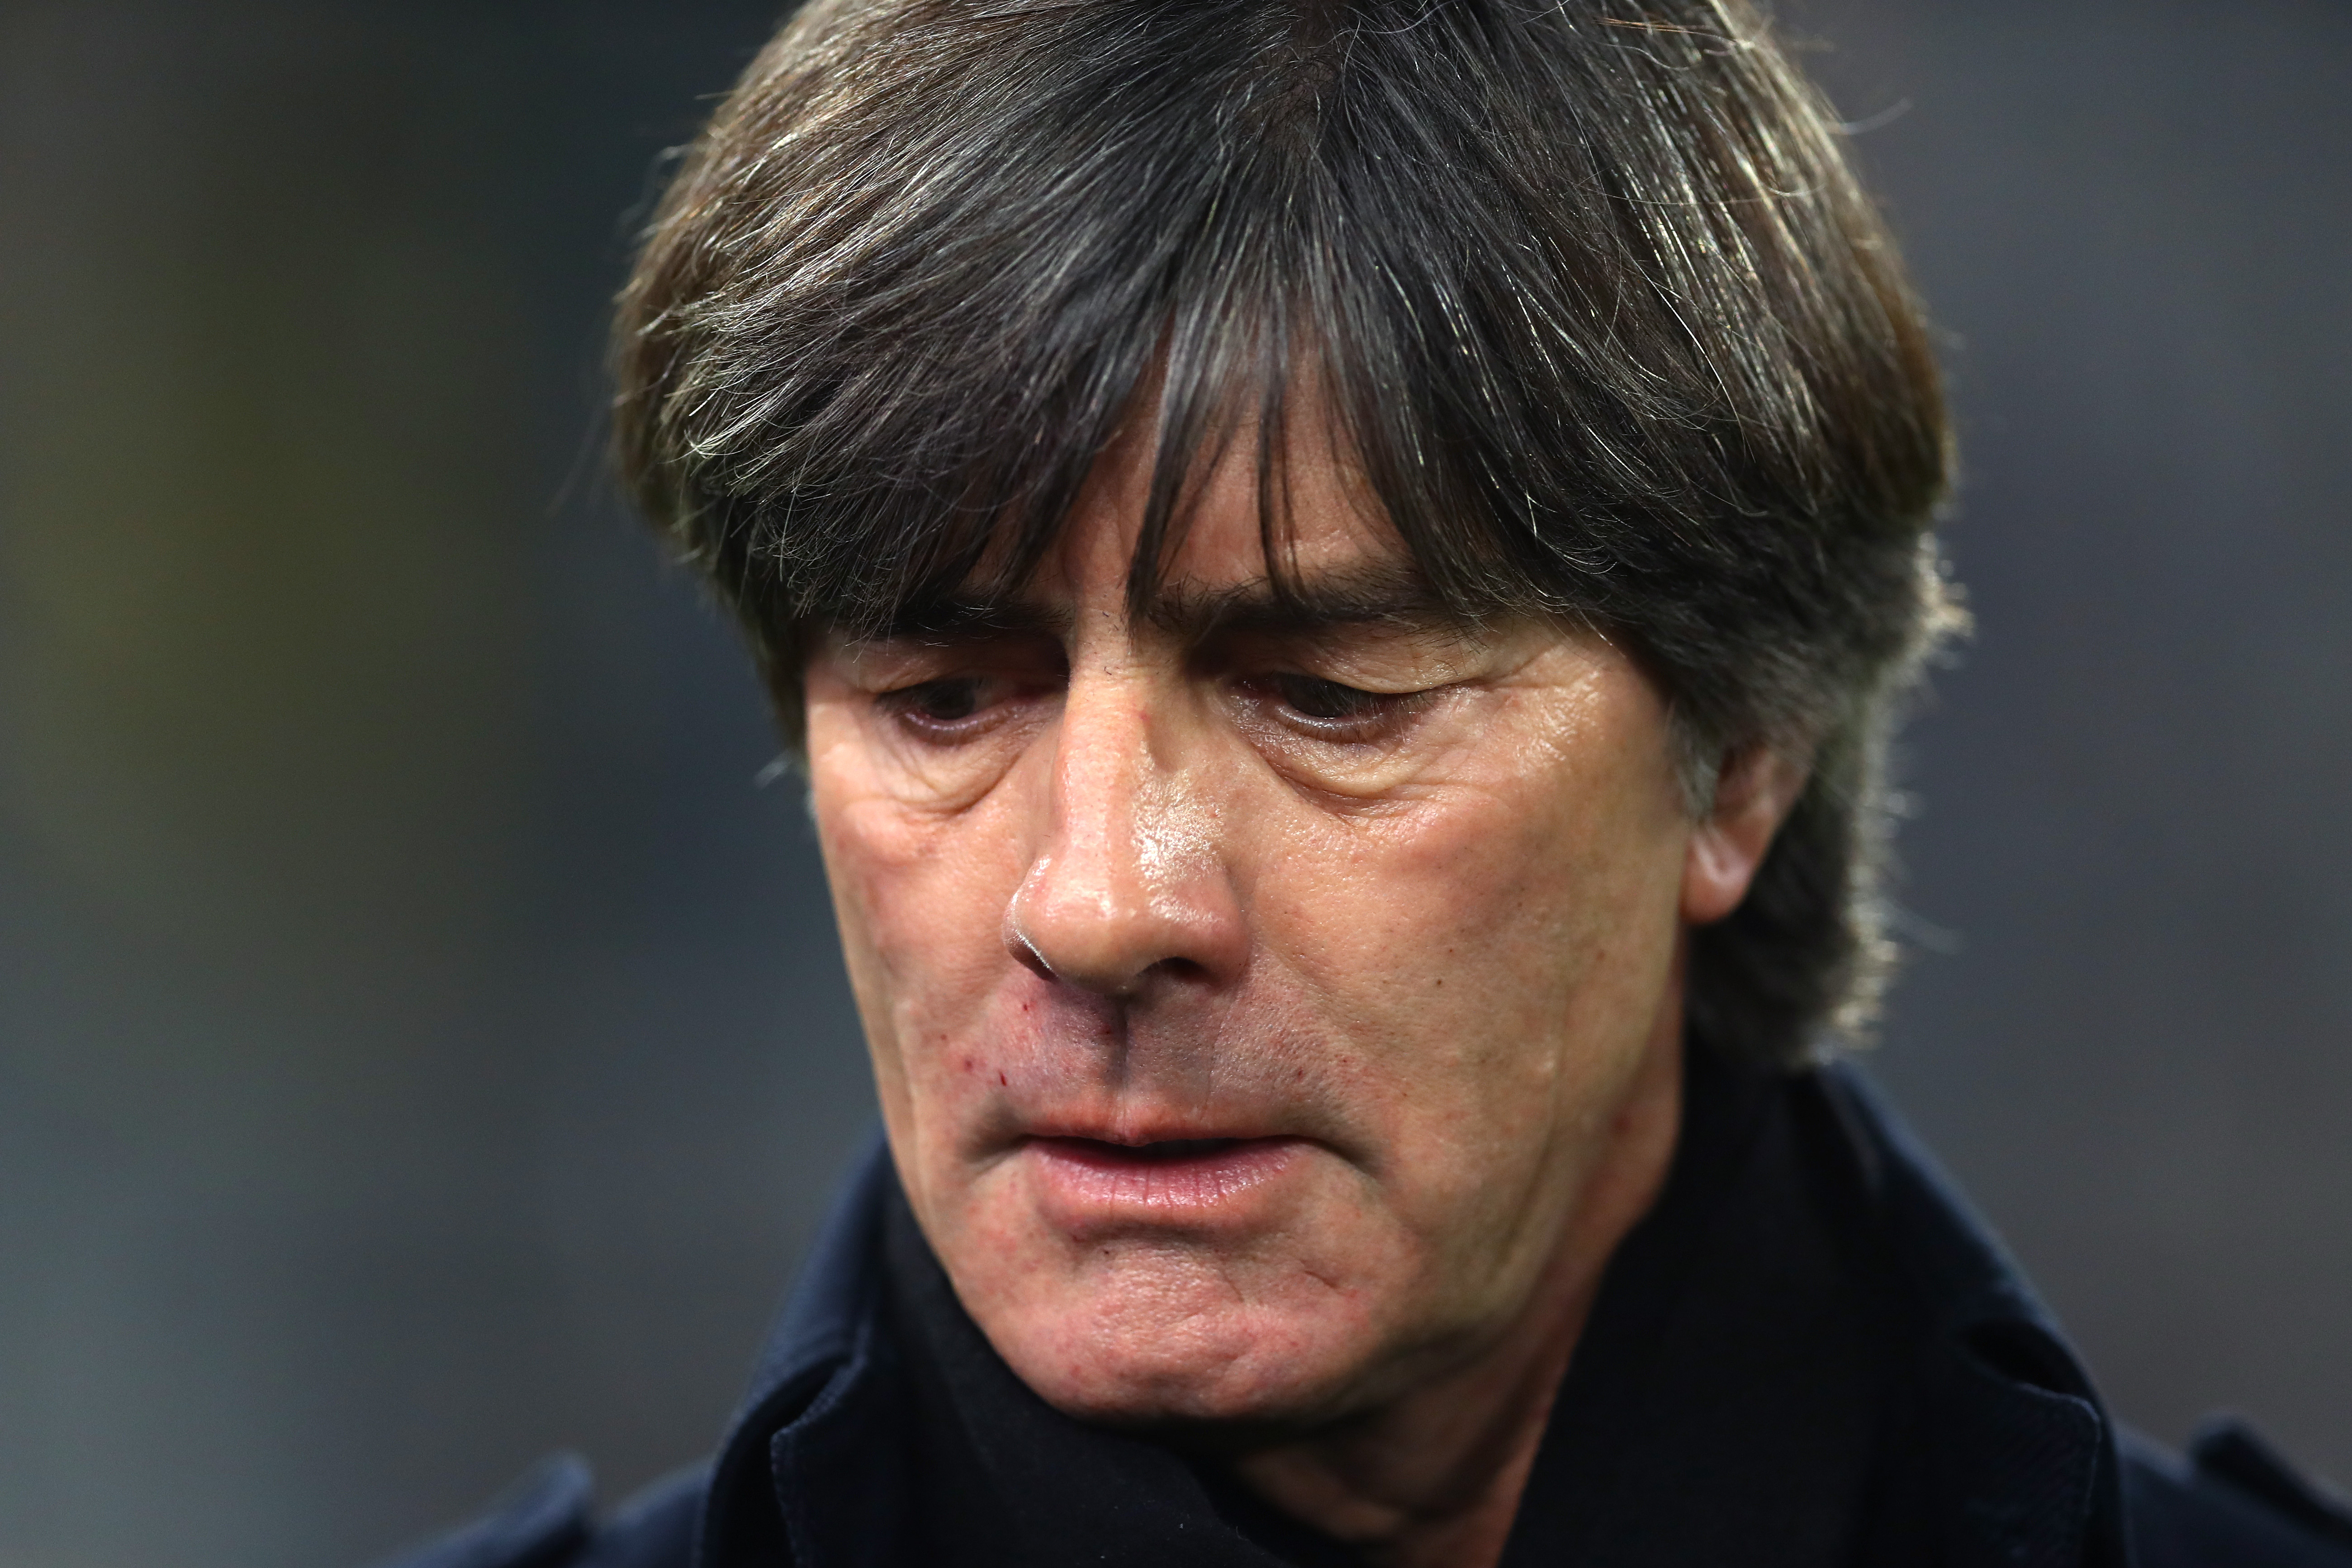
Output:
[{"xmin": 696, "ymin": 1065, "xmax": 2129, "ymax": 1568}]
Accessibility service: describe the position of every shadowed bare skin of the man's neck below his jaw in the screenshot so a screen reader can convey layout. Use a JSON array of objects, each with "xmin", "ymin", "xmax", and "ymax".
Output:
[{"xmin": 1233, "ymin": 1029, "xmax": 1682, "ymax": 1568}]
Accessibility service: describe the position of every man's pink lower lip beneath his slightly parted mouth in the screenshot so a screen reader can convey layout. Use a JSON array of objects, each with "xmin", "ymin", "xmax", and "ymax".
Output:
[{"xmin": 1023, "ymin": 1138, "xmax": 1303, "ymax": 1230}]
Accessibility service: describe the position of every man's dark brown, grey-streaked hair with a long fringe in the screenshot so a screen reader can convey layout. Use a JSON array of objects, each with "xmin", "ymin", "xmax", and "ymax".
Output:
[{"xmin": 614, "ymin": 0, "xmax": 1957, "ymax": 1065}]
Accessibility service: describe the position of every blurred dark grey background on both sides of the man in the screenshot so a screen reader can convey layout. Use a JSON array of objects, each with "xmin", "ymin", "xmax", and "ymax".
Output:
[{"xmin": 0, "ymin": 0, "xmax": 2352, "ymax": 1568}]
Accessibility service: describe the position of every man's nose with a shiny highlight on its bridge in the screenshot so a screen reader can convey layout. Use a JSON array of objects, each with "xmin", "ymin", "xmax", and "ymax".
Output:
[{"xmin": 1004, "ymin": 675, "xmax": 1247, "ymax": 999}]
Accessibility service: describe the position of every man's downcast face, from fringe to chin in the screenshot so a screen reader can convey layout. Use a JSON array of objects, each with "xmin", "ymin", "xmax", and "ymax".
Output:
[{"xmin": 807, "ymin": 411, "xmax": 1693, "ymax": 1422}]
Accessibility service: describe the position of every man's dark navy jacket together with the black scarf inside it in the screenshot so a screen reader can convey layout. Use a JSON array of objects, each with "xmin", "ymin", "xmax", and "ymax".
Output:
[{"xmin": 404, "ymin": 1051, "xmax": 2352, "ymax": 1568}]
